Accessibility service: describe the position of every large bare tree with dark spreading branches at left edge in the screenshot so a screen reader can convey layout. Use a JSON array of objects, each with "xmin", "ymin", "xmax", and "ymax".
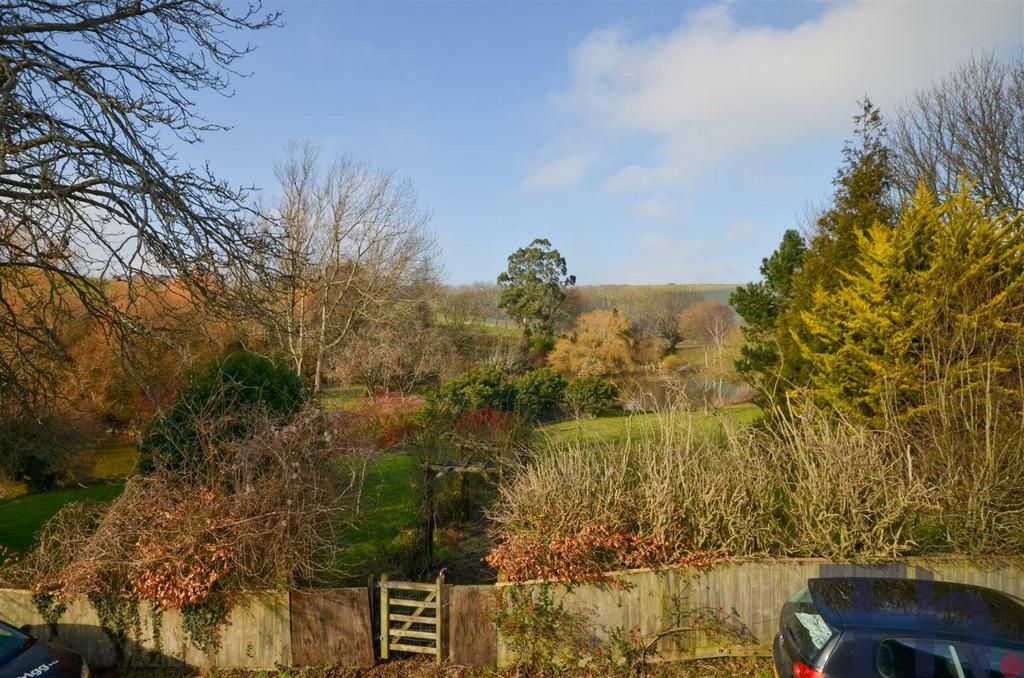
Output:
[{"xmin": 0, "ymin": 0, "xmax": 278, "ymax": 417}]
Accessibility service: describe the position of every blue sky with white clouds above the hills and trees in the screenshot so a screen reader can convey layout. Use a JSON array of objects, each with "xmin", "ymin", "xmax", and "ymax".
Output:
[{"xmin": 184, "ymin": 0, "xmax": 1024, "ymax": 285}]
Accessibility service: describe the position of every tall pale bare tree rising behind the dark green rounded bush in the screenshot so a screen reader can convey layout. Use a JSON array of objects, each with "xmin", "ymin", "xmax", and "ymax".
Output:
[{"xmin": 265, "ymin": 144, "xmax": 437, "ymax": 391}]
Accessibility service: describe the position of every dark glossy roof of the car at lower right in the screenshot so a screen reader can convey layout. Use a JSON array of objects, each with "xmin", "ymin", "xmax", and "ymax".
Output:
[{"xmin": 807, "ymin": 577, "xmax": 1024, "ymax": 643}]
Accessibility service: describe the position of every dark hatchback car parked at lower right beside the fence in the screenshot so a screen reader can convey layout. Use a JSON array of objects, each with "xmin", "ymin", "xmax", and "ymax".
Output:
[{"xmin": 774, "ymin": 578, "xmax": 1024, "ymax": 678}]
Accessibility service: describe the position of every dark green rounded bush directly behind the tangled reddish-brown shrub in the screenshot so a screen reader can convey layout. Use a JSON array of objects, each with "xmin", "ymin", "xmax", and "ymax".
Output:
[{"xmin": 138, "ymin": 351, "xmax": 306, "ymax": 473}]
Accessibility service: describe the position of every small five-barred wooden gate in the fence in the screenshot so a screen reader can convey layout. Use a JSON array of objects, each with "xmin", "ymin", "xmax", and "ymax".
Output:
[{"xmin": 380, "ymin": 570, "xmax": 444, "ymax": 664}]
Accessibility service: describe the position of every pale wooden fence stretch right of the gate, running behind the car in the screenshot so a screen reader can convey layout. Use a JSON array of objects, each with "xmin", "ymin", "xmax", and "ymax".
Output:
[{"xmin": 498, "ymin": 558, "xmax": 1024, "ymax": 665}]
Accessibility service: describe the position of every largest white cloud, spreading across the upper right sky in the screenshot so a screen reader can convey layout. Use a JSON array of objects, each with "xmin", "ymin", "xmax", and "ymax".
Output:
[{"xmin": 561, "ymin": 2, "xmax": 1024, "ymax": 192}]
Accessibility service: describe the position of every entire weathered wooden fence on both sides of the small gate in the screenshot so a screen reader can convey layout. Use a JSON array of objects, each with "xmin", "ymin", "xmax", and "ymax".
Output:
[{"xmin": 0, "ymin": 558, "xmax": 1024, "ymax": 669}]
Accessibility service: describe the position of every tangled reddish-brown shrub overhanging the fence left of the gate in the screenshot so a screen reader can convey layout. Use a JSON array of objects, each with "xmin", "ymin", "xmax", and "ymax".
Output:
[{"xmin": 16, "ymin": 410, "xmax": 361, "ymax": 610}]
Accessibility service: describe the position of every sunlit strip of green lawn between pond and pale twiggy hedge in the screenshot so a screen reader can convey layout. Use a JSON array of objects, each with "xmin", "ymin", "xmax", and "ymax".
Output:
[{"xmin": 534, "ymin": 405, "xmax": 762, "ymax": 444}]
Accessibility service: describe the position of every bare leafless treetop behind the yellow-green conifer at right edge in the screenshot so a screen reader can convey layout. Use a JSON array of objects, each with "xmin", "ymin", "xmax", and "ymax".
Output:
[{"xmin": 891, "ymin": 54, "xmax": 1024, "ymax": 212}]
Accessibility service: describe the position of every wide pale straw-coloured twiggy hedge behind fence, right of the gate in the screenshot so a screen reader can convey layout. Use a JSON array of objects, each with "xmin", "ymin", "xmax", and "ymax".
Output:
[{"xmin": 488, "ymin": 403, "xmax": 936, "ymax": 581}]
